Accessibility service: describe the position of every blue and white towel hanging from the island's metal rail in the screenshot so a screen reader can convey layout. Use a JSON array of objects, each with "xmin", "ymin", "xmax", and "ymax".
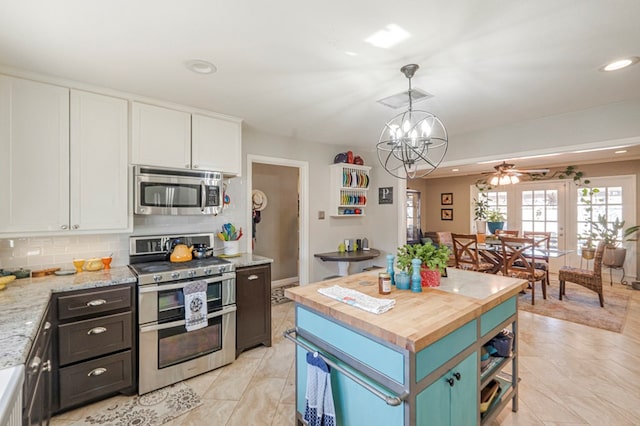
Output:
[{"xmin": 304, "ymin": 352, "xmax": 336, "ymax": 426}]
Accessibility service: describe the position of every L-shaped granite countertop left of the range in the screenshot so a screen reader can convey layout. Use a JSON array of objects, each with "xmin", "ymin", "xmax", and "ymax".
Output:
[{"xmin": 0, "ymin": 266, "xmax": 136, "ymax": 369}]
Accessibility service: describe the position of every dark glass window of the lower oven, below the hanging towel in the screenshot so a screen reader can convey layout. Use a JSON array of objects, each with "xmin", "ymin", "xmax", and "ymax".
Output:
[{"xmin": 158, "ymin": 316, "xmax": 222, "ymax": 369}]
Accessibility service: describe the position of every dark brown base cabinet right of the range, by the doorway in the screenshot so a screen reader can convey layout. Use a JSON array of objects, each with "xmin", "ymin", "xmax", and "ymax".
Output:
[{"xmin": 236, "ymin": 263, "xmax": 271, "ymax": 356}]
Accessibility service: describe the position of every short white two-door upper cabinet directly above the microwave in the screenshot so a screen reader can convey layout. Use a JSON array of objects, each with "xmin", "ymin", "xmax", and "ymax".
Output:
[{"xmin": 131, "ymin": 102, "xmax": 242, "ymax": 176}]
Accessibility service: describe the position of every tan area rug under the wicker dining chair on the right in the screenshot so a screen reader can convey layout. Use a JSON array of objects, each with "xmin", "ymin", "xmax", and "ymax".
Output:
[{"xmin": 518, "ymin": 281, "xmax": 632, "ymax": 333}]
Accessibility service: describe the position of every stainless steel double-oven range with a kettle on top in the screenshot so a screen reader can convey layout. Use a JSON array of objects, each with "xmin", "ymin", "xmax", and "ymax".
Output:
[{"xmin": 129, "ymin": 233, "xmax": 236, "ymax": 394}]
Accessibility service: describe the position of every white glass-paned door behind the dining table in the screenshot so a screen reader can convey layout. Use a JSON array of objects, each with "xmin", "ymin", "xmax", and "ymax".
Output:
[{"xmin": 509, "ymin": 182, "xmax": 567, "ymax": 273}]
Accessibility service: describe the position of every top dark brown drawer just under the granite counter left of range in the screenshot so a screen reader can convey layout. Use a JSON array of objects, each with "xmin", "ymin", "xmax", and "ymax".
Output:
[{"xmin": 58, "ymin": 286, "xmax": 131, "ymax": 320}]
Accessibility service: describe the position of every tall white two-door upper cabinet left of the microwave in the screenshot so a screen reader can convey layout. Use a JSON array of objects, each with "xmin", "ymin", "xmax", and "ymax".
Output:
[{"xmin": 0, "ymin": 76, "xmax": 132, "ymax": 236}]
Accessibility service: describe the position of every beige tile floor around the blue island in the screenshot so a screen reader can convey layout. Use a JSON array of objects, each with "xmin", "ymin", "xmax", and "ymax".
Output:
[{"xmin": 52, "ymin": 278, "xmax": 640, "ymax": 426}]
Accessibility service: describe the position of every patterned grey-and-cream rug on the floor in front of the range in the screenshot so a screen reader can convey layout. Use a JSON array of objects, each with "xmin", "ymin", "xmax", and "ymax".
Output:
[{"xmin": 72, "ymin": 382, "xmax": 202, "ymax": 426}]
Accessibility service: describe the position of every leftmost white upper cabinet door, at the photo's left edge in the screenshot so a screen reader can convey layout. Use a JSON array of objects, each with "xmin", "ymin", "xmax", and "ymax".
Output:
[{"xmin": 0, "ymin": 76, "xmax": 69, "ymax": 233}]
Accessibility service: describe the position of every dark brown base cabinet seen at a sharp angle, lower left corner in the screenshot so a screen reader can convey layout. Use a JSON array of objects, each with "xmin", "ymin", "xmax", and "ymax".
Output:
[{"xmin": 22, "ymin": 305, "xmax": 53, "ymax": 426}]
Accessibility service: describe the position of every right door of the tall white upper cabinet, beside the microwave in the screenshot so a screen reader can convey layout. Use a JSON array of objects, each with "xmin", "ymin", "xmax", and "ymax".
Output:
[{"xmin": 69, "ymin": 90, "xmax": 129, "ymax": 231}]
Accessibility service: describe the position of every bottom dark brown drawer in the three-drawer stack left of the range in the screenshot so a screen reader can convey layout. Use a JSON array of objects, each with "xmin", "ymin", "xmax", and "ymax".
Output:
[{"xmin": 59, "ymin": 351, "xmax": 132, "ymax": 409}]
